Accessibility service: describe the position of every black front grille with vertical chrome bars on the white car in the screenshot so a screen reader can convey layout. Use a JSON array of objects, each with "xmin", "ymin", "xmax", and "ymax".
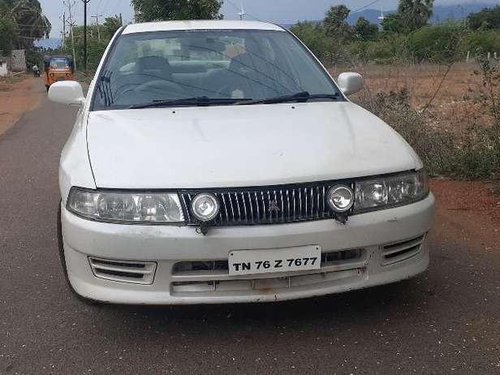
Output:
[{"xmin": 181, "ymin": 181, "xmax": 352, "ymax": 226}]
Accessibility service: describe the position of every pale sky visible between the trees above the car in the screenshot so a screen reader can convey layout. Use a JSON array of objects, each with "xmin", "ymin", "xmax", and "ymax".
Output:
[{"xmin": 39, "ymin": 0, "xmax": 500, "ymax": 38}]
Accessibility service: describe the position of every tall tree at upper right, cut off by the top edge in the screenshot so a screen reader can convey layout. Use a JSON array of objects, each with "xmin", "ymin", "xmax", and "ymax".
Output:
[{"xmin": 397, "ymin": 0, "xmax": 434, "ymax": 33}]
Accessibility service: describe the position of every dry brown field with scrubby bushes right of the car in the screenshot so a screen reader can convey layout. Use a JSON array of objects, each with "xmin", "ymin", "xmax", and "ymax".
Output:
[{"xmin": 332, "ymin": 61, "xmax": 500, "ymax": 185}]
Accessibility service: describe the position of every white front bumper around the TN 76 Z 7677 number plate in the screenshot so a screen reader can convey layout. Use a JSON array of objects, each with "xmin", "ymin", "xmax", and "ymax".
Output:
[{"xmin": 61, "ymin": 195, "xmax": 434, "ymax": 305}]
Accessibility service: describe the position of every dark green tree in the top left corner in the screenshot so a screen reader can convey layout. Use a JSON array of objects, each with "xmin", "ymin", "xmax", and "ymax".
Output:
[{"xmin": 0, "ymin": 0, "xmax": 51, "ymax": 49}]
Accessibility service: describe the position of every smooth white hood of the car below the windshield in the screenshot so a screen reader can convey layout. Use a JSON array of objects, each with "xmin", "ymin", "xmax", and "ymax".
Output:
[{"xmin": 87, "ymin": 102, "xmax": 421, "ymax": 189}]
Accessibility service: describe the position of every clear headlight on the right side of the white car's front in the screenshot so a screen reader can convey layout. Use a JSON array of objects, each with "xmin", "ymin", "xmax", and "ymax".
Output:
[{"xmin": 354, "ymin": 170, "xmax": 429, "ymax": 212}]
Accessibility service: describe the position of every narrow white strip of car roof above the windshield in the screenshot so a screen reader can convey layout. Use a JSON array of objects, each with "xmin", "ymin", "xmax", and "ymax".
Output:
[{"xmin": 123, "ymin": 21, "xmax": 284, "ymax": 34}]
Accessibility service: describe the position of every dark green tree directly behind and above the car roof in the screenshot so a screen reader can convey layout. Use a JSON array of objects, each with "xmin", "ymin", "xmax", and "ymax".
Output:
[{"xmin": 132, "ymin": 0, "xmax": 222, "ymax": 22}]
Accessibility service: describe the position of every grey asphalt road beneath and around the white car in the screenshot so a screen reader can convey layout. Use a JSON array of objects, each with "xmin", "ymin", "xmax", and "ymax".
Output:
[{"xmin": 0, "ymin": 86, "xmax": 500, "ymax": 375}]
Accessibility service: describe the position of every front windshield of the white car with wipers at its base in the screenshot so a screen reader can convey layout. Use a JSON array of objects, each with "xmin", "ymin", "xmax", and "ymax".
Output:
[{"xmin": 92, "ymin": 30, "xmax": 342, "ymax": 110}]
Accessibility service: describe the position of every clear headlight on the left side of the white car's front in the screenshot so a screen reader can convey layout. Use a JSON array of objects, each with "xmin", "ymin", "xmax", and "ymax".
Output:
[{"xmin": 67, "ymin": 188, "xmax": 184, "ymax": 224}]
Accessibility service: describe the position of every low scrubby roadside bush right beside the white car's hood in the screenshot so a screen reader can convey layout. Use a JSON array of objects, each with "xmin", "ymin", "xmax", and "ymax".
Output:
[{"xmin": 360, "ymin": 89, "xmax": 500, "ymax": 179}]
